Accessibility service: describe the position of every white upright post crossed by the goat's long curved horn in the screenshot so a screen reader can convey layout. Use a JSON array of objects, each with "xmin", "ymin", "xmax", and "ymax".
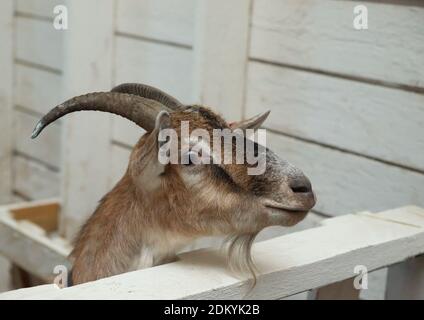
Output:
[{"xmin": 60, "ymin": 0, "xmax": 114, "ymax": 239}]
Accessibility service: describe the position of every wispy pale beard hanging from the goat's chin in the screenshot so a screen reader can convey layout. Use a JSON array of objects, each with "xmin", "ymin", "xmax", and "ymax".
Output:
[{"xmin": 224, "ymin": 233, "xmax": 258, "ymax": 288}]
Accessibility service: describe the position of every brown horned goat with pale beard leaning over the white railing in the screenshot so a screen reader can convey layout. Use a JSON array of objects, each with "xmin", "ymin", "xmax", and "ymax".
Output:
[{"xmin": 32, "ymin": 84, "xmax": 316, "ymax": 284}]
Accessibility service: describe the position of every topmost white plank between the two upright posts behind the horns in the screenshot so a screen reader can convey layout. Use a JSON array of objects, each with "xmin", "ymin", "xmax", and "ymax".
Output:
[{"xmin": 116, "ymin": 0, "xmax": 196, "ymax": 46}]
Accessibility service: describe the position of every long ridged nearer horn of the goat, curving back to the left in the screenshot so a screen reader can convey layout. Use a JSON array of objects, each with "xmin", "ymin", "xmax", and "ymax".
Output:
[{"xmin": 31, "ymin": 92, "xmax": 167, "ymax": 139}]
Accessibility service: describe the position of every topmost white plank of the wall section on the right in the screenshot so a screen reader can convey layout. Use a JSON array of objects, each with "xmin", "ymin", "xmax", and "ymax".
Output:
[{"xmin": 250, "ymin": 0, "xmax": 424, "ymax": 87}]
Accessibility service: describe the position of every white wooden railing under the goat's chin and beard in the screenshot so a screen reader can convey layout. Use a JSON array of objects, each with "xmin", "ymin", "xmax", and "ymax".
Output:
[{"xmin": 0, "ymin": 206, "xmax": 424, "ymax": 299}]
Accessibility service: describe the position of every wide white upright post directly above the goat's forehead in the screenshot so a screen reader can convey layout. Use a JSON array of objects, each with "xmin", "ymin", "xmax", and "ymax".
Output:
[{"xmin": 194, "ymin": 0, "xmax": 251, "ymax": 121}]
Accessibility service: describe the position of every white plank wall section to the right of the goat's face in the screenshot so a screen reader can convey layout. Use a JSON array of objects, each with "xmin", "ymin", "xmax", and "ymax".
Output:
[{"xmin": 245, "ymin": 0, "xmax": 424, "ymax": 215}]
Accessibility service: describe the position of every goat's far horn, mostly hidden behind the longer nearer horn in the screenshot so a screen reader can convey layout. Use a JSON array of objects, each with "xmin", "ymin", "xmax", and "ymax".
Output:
[{"xmin": 111, "ymin": 83, "xmax": 184, "ymax": 110}]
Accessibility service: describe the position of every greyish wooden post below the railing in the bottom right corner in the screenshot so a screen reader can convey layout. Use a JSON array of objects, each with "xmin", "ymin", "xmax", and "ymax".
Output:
[{"xmin": 386, "ymin": 255, "xmax": 424, "ymax": 300}]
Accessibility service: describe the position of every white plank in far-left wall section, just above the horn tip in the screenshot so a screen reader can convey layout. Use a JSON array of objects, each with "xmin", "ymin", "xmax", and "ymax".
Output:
[{"xmin": 14, "ymin": 64, "xmax": 63, "ymax": 114}]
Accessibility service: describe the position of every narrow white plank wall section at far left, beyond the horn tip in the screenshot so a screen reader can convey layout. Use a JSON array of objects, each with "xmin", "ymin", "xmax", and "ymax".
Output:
[{"xmin": 12, "ymin": 0, "xmax": 63, "ymax": 201}]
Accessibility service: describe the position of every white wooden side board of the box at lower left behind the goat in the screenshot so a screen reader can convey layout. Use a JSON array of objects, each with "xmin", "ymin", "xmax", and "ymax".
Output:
[{"xmin": 0, "ymin": 211, "xmax": 71, "ymax": 279}]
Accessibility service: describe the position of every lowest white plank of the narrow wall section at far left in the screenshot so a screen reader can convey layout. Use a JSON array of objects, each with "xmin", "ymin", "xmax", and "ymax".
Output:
[{"xmin": 13, "ymin": 156, "xmax": 60, "ymax": 199}]
